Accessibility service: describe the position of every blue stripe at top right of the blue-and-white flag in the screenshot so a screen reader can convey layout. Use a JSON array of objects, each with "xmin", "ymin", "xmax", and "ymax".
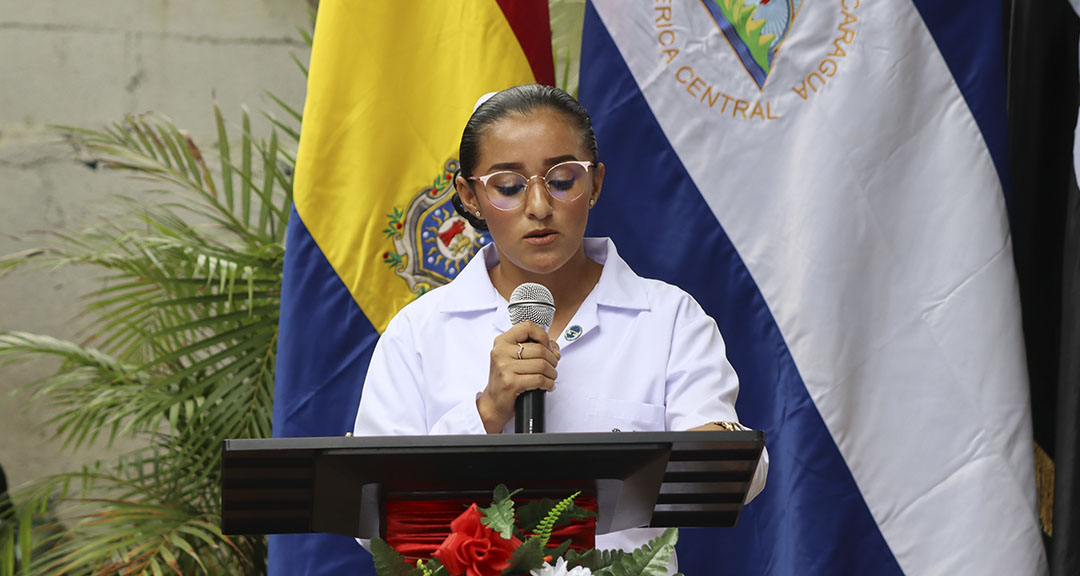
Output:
[{"xmin": 914, "ymin": 0, "xmax": 1012, "ymax": 205}]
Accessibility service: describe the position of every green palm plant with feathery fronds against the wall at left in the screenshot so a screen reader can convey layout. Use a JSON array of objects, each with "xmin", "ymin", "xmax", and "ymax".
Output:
[{"xmin": 0, "ymin": 96, "xmax": 302, "ymax": 575}]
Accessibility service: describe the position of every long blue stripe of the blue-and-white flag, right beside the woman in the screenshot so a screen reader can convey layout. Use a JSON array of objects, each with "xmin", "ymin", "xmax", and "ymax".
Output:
[{"xmin": 579, "ymin": 2, "xmax": 902, "ymax": 575}]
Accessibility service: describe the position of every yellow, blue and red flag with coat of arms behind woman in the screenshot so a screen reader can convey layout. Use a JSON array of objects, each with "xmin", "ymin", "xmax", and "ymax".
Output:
[{"xmin": 269, "ymin": 0, "xmax": 554, "ymax": 576}]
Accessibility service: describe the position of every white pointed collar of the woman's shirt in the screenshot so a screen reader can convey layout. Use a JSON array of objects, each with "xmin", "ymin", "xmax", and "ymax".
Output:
[{"xmin": 438, "ymin": 238, "xmax": 649, "ymax": 319}]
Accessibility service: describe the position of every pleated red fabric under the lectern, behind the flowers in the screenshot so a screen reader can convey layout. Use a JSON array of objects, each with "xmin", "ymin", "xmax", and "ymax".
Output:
[{"xmin": 386, "ymin": 496, "xmax": 597, "ymax": 559}]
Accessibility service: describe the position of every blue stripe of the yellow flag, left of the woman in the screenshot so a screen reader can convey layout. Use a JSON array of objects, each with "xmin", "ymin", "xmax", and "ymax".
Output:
[{"xmin": 268, "ymin": 207, "xmax": 379, "ymax": 576}]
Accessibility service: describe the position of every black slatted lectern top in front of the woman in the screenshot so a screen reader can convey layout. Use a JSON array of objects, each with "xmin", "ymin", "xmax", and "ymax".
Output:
[{"xmin": 221, "ymin": 431, "xmax": 765, "ymax": 538}]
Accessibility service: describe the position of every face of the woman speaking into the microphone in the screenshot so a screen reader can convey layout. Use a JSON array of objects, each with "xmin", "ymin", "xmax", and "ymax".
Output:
[{"xmin": 458, "ymin": 109, "xmax": 604, "ymax": 276}]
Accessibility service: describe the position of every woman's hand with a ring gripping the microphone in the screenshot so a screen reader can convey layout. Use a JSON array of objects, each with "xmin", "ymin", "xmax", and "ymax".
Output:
[{"xmin": 476, "ymin": 322, "xmax": 562, "ymax": 434}]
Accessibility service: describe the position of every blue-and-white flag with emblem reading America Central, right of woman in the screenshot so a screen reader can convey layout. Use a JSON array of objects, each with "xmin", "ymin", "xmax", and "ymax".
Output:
[{"xmin": 580, "ymin": 0, "xmax": 1047, "ymax": 575}]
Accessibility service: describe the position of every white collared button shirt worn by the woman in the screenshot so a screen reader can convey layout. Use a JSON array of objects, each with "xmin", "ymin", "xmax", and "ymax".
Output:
[{"xmin": 353, "ymin": 238, "xmax": 768, "ymax": 547}]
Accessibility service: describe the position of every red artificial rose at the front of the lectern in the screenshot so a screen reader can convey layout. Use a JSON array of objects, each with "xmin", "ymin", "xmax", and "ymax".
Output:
[{"xmin": 434, "ymin": 504, "xmax": 522, "ymax": 576}]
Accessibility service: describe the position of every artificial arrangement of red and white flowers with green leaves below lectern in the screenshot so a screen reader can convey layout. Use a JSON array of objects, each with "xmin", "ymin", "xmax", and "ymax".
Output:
[{"xmin": 372, "ymin": 484, "xmax": 681, "ymax": 576}]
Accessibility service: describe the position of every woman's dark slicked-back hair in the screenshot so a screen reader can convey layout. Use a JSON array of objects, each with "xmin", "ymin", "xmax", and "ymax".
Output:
[{"xmin": 454, "ymin": 84, "xmax": 599, "ymax": 230}]
